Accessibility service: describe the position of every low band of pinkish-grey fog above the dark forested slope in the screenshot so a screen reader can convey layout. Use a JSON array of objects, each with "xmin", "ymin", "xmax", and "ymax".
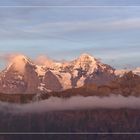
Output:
[{"xmin": 0, "ymin": 95, "xmax": 140, "ymax": 113}]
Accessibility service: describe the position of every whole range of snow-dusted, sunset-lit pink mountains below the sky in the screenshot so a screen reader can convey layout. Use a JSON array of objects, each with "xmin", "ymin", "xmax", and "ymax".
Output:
[{"xmin": 0, "ymin": 54, "xmax": 140, "ymax": 94}]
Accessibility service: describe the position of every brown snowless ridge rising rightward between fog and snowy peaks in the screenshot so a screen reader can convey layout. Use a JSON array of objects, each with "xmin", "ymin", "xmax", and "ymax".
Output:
[{"xmin": 40, "ymin": 71, "xmax": 140, "ymax": 99}]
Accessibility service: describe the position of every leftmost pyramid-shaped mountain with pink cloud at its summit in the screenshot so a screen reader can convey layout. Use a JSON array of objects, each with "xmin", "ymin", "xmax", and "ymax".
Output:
[{"xmin": 0, "ymin": 55, "xmax": 39, "ymax": 93}]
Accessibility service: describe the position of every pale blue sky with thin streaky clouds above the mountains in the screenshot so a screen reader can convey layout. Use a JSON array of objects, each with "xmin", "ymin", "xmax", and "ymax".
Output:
[{"xmin": 0, "ymin": 0, "xmax": 140, "ymax": 68}]
